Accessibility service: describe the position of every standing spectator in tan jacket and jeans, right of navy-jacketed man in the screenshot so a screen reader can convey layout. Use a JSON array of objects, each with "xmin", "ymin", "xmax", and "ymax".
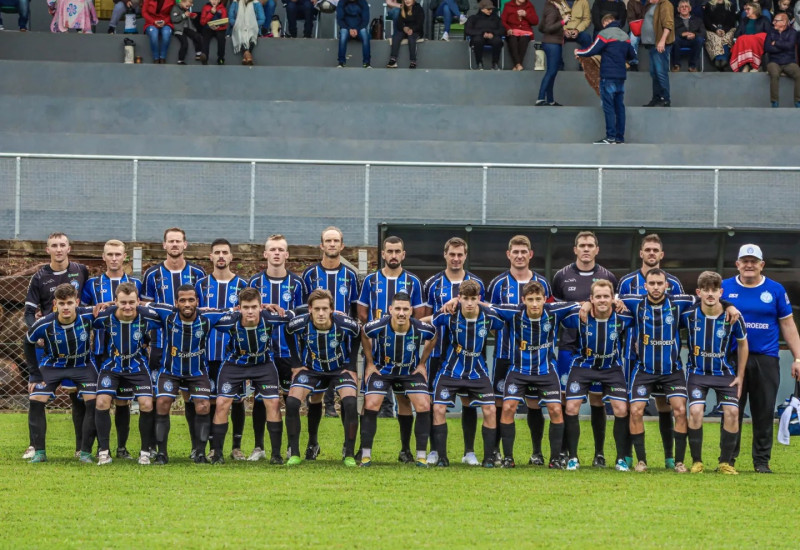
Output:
[{"xmin": 642, "ymin": 0, "xmax": 675, "ymax": 107}]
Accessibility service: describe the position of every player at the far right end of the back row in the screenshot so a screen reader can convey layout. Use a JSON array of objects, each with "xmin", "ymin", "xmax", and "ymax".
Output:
[{"xmin": 617, "ymin": 233, "xmax": 683, "ymax": 469}]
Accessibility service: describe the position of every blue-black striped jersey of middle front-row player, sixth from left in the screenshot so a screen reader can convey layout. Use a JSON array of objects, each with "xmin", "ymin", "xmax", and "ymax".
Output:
[{"xmin": 364, "ymin": 315, "xmax": 436, "ymax": 376}]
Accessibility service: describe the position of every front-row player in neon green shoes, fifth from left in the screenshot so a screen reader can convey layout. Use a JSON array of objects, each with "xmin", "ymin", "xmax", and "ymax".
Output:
[{"xmin": 286, "ymin": 288, "xmax": 359, "ymax": 466}]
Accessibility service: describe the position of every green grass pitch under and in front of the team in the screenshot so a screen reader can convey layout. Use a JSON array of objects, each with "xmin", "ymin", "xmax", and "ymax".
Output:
[{"xmin": 0, "ymin": 413, "xmax": 800, "ymax": 548}]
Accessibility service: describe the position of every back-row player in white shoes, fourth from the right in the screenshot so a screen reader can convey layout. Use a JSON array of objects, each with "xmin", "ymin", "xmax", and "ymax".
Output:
[{"xmin": 423, "ymin": 237, "xmax": 485, "ymax": 466}]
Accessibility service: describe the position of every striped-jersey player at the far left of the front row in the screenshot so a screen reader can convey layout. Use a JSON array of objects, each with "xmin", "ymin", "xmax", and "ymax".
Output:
[{"xmin": 25, "ymin": 283, "xmax": 97, "ymax": 463}]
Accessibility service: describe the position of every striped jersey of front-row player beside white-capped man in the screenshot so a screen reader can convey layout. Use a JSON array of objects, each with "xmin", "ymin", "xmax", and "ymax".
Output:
[{"xmin": 681, "ymin": 304, "xmax": 747, "ymax": 376}]
